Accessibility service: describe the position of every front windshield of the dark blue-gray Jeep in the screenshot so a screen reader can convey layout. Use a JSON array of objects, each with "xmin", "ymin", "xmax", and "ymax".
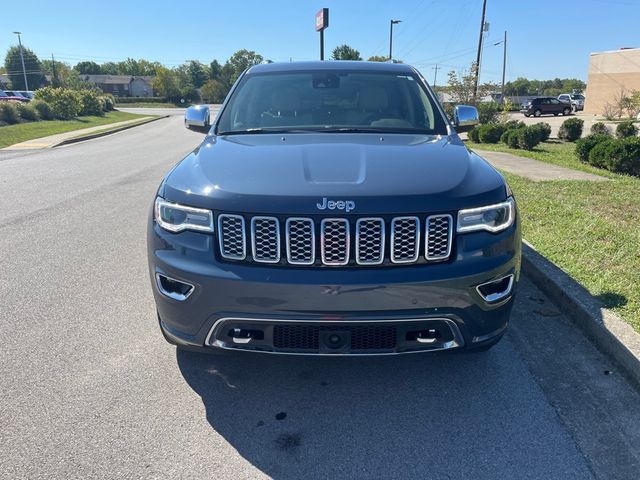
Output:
[{"xmin": 218, "ymin": 70, "xmax": 447, "ymax": 135}]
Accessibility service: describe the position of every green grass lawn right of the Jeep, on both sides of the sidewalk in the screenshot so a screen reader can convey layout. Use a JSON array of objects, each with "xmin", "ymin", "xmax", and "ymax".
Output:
[{"xmin": 469, "ymin": 143, "xmax": 640, "ymax": 332}]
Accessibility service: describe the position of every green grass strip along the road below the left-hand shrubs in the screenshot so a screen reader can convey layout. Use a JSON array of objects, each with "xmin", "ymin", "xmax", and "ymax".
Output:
[{"xmin": 0, "ymin": 111, "xmax": 145, "ymax": 148}]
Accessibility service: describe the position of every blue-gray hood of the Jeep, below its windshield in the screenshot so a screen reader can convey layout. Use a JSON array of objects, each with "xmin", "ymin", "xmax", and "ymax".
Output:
[{"xmin": 160, "ymin": 133, "xmax": 506, "ymax": 215}]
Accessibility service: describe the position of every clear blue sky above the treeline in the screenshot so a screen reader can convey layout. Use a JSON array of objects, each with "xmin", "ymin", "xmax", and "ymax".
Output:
[{"xmin": 0, "ymin": 0, "xmax": 640, "ymax": 83}]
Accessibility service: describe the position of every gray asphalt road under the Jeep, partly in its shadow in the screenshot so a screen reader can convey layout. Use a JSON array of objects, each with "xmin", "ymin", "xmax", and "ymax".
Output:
[{"xmin": 0, "ymin": 116, "xmax": 640, "ymax": 479}]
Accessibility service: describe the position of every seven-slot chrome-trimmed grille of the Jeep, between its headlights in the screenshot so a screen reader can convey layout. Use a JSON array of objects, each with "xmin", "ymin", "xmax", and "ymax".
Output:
[{"xmin": 217, "ymin": 213, "xmax": 453, "ymax": 266}]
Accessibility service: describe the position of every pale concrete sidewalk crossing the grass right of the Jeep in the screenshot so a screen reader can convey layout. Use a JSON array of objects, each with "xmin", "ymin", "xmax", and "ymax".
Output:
[{"xmin": 474, "ymin": 149, "xmax": 608, "ymax": 182}]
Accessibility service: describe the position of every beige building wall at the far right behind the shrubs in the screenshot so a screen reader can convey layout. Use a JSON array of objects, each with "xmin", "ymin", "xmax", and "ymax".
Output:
[{"xmin": 584, "ymin": 48, "xmax": 640, "ymax": 115}]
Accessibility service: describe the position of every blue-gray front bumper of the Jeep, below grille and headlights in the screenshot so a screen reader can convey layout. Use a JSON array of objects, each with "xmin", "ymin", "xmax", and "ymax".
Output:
[{"xmin": 148, "ymin": 218, "xmax": 521, "ymax": 354}]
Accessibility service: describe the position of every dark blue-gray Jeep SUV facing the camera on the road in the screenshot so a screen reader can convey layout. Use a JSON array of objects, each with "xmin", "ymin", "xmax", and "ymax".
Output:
[{"xmin": 148, "ymin": 62, "xmax": 521, "ymax": 355}]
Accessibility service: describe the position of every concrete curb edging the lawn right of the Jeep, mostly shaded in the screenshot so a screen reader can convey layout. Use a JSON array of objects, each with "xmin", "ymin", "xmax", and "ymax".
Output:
[{"xmin": 522, "ymin": 241, "xmax": 640, "ymax": 386}]
